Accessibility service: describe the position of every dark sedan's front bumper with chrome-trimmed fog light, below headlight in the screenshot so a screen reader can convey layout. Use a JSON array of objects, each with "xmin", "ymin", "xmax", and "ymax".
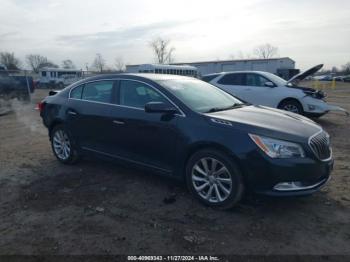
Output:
[{"xmin": 244, "ymin": 152, "xmax": 334, "ymax": 196}]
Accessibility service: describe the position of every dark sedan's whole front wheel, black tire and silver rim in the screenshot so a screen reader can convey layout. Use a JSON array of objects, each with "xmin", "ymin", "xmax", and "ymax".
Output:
[{"xmin": 186, "ymin": 149, "xmax": 244, "ymax": 209}]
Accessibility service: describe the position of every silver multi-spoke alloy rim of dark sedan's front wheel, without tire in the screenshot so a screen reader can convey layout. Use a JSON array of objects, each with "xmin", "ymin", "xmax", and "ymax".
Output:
[{"xmin": 191, "ymin": 157, "xmax": 232, "ymax": 203}]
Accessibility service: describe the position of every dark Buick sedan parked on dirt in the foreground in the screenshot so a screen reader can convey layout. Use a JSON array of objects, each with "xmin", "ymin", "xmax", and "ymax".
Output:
[{"xmin": 39, "ymin": 74, "xmax": 333, "ymax": 208}]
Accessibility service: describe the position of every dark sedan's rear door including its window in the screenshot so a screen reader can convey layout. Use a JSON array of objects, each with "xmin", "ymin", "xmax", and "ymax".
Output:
[{"xmin": 67, "ymin": 80, "xmax": 116, "ymax": 152}]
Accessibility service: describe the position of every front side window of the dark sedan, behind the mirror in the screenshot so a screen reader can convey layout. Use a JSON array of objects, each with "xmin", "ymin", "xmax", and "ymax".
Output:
[{"xmin": 119, "ymin": 80, "xmax": 169, "ymax": 109}]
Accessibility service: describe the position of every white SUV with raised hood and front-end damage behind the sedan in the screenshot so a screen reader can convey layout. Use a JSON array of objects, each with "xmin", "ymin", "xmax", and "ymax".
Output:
[{"xmin": 202, "ymin": 64, "xmax": 345, "ymax": 117}]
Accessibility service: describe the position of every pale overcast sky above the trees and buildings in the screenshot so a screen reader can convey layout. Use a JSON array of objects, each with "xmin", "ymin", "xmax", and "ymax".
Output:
[{"xmin": 0, "ymin": 0, "xmax": 350, "ymax": 69}]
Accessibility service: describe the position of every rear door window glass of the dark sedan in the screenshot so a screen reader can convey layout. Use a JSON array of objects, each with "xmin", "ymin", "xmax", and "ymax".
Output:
[{"xmin": 82, "ymin": 81, "xmax": 113, "ymax": 103}]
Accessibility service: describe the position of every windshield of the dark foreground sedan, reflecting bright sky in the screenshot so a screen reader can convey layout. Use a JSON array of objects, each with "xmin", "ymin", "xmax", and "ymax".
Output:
[{"xmin": 158, "ymin": 79, "xmax": 243, "ymax": 113}]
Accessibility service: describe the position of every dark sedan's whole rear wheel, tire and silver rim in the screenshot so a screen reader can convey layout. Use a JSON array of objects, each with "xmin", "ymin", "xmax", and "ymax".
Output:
[{"xmin": 50, "ymin": 125, "xmax": 79, "ymax": 164}]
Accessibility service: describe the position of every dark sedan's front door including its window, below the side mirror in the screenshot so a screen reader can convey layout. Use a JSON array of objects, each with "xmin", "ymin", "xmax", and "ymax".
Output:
[{"xmin": 111, "ymin": 80, "xmax": 180, "ymax": 171}]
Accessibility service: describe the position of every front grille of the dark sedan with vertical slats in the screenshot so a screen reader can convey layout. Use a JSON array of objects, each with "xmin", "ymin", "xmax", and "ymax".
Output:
[{"xmin": 309, "ymin": 131, "xmax": 331, "ymax": 160}]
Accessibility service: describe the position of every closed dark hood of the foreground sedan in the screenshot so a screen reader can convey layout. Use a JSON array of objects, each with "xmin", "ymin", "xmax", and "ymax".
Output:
[{"xmin": 206, "ymin": 106, "xmax": 322, "ymax": 141}]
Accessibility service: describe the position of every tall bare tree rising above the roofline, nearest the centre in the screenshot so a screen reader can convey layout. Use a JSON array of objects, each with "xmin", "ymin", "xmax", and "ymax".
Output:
[{"xmin": 150, "ymin": 37, "xmax": 175, "ymax": 64}]
